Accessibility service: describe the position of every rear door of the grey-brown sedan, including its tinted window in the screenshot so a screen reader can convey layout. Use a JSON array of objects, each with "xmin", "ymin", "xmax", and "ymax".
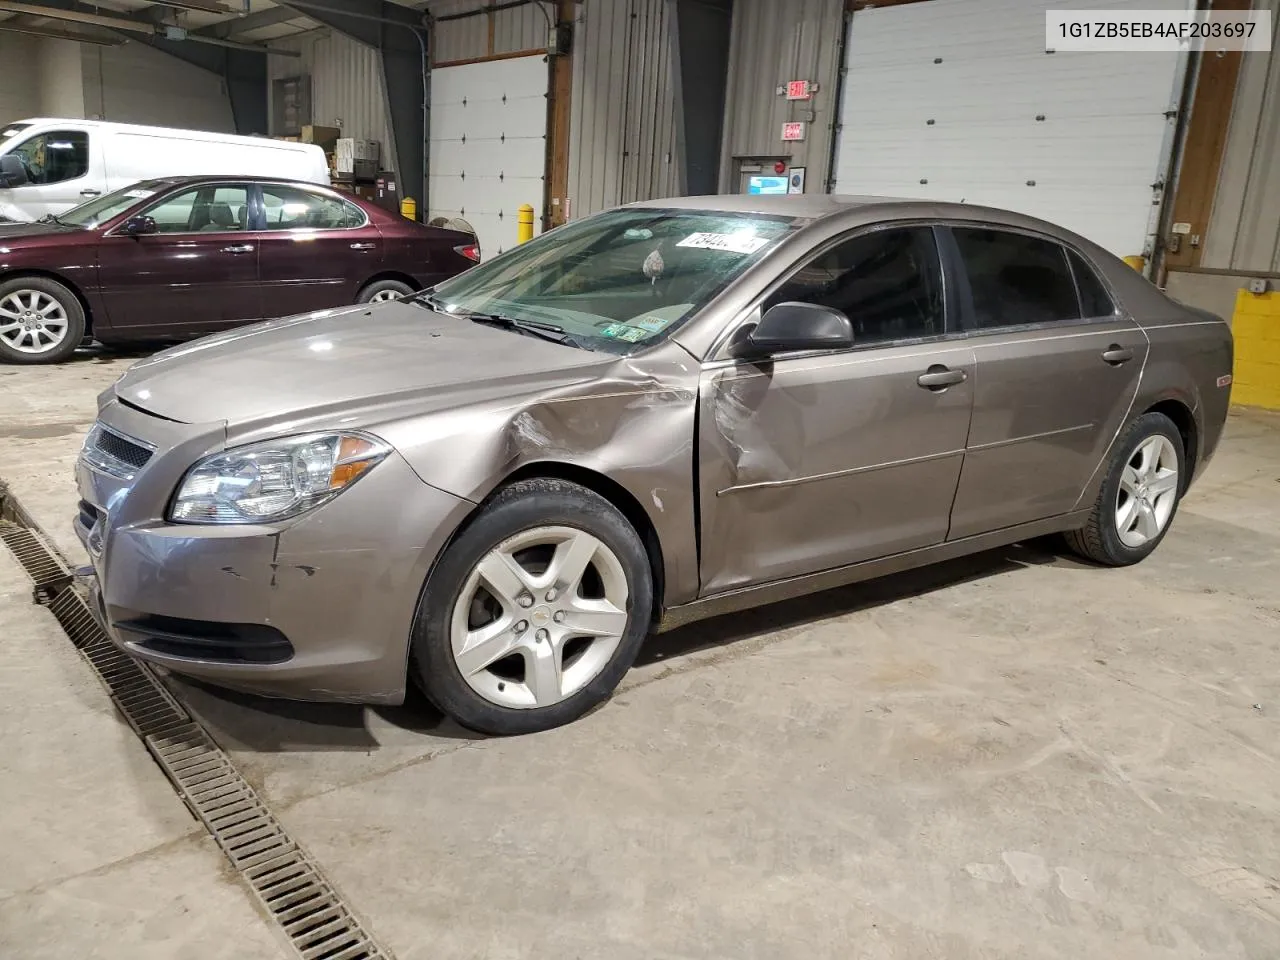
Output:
[{"xmin": 943, "ymin": 225, "xmax": 1147, "ymax": 539}]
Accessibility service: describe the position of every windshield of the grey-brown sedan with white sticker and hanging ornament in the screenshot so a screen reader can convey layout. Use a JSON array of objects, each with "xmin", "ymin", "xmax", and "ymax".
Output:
[{"xmin": 430, "ymin": 207, "xmax": 794, "ymax": 353}]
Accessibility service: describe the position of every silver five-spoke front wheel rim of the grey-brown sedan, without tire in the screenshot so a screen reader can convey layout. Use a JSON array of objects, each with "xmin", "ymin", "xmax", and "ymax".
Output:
[{"xmin": 449, "ymin": 526, "xmax": 628, "ymax": 709}]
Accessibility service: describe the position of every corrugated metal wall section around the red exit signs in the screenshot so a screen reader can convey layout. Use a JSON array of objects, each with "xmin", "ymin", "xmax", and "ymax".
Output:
[{"xmin": 721, "ymin": 0, "xmax": 844, "ymax": 193}]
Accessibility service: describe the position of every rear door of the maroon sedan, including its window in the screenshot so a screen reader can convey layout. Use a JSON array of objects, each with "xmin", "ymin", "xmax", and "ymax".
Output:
[{"xmin": 255, "ymin": 183, "xmax": 383, "ymax": 316}]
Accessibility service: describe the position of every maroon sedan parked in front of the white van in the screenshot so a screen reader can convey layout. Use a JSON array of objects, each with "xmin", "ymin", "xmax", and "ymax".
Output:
[{"xmin": 0, "ymin": 177, "xmax": 480, "ymax": 364}]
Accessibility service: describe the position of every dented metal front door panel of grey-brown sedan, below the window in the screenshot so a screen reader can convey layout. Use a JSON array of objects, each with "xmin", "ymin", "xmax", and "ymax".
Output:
[{"xmin": 699, "ymin": 343, "xmax": 974, "ymax": 595}]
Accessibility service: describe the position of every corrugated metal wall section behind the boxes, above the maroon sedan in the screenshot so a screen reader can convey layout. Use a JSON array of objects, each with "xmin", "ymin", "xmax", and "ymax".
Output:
[{"xmin": 266, "ymin": 29, "xmax": 396, "ymax": 163}]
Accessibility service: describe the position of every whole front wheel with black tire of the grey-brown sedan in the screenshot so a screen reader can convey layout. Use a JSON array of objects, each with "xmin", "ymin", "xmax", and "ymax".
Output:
[{"xmin": 411, "ymin": 479, "xmax": 654, "ymax": 736}]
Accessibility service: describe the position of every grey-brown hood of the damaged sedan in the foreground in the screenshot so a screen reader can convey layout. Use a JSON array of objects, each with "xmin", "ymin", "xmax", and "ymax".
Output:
[{"xmin": 114, "ymin": 302, "xmax": 617, "ymax": 428}]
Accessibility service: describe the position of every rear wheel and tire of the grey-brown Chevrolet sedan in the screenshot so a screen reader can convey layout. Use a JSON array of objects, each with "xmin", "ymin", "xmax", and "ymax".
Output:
[{"xmin": 1066, "ymin": 413, "xmax": 1187, "ymax": 567}]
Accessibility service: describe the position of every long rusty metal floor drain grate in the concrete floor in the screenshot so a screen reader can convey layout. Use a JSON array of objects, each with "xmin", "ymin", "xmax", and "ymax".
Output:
[{"xmin": 0, "ymin": 512, "xmax": 390, "ymax": 960}]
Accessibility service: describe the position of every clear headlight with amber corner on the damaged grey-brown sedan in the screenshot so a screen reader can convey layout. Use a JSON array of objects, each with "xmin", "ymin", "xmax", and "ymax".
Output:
[{"xmin": 169, "ymin": 433, "xmax": 390, "ymax": 524}]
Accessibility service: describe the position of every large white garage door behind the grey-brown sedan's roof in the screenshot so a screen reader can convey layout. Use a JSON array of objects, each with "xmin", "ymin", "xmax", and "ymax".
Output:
[{"xmin": 835, "ymin": 0, "xmax": 1184, "ymax": 256}]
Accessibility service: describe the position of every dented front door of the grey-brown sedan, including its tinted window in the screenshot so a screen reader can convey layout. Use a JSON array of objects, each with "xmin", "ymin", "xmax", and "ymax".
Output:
[{"xmin": 698, "ymin": 227, "xmax": 974, "ymax": 595}]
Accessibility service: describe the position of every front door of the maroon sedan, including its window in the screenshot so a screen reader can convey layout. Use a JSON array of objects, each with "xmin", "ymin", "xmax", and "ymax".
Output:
[{"xmin": 99, "ymin": 183, "xmax": 262, "ymax": 337}]
